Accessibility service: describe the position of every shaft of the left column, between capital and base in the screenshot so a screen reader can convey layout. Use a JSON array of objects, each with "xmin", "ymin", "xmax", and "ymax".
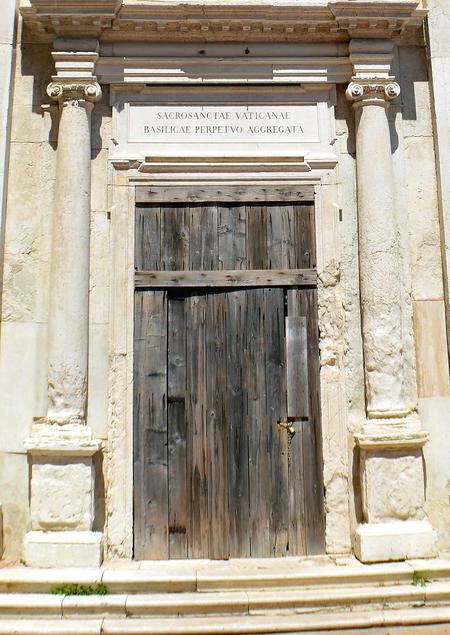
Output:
[{"xmin": 47, "ymin": 99, "xmax": 93, "ymax": 423}]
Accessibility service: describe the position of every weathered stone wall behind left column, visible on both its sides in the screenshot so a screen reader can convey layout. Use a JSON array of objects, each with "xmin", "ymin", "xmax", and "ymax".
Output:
[{"xmin": 0, "ymin": 18, "xmax": 110, "ymax": 559}]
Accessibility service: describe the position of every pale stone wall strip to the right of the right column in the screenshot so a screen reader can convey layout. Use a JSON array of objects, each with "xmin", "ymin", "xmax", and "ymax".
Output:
[{"xmin": 396, "ymin": 42, "xmax": 450, "ymax": 548}]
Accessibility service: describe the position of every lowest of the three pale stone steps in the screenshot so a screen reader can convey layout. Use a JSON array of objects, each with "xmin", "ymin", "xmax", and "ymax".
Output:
[{"xmin": 0, "ymin": 607, "xmax": 450, "ymax": 635}]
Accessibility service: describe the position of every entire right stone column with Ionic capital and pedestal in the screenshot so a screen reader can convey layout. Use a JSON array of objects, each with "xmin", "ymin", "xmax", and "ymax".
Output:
[{"xmin": 347, "ymin": 40, "xmax": 435, "ymax": 562}]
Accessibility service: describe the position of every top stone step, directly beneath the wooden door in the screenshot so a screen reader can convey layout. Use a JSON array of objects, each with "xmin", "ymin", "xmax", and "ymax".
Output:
[{"xmin": 0, "ymin": 558, "xmax": 450, "ymax": 594}]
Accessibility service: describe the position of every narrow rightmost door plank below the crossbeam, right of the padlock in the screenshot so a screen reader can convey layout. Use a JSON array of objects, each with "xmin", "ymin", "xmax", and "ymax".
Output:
[{"xmin": 297, "ymin": 289, "xmax": 325, "ymax": 554}]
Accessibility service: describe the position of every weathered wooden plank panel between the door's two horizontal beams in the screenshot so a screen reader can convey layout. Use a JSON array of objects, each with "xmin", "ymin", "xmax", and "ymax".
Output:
[{"xmin": 135, "ymin": 203, "xmax": 315, "ymax": 271}]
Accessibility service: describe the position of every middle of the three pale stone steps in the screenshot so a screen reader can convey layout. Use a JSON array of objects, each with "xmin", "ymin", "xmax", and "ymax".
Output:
[{"xmin": 0, "ymin": 581, "xmax": 450, "ymax": 621}]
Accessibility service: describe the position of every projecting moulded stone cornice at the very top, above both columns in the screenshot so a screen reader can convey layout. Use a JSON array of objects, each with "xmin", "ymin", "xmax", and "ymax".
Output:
[{"xmin": 21, "ymin": 0, "xmax": 425, "ymax": 41}]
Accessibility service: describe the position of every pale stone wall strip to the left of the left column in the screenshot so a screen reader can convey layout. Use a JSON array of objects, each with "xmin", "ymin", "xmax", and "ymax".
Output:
[{"xmin": 0, "ymin": 17, "xmax": 55, "ymax": 559}]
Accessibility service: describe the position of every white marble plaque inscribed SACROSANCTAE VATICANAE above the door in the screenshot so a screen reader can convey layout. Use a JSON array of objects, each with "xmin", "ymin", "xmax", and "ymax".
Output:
[{"xmin": 128, "ymin": 104, "xmax": 319, "ymax": 143}]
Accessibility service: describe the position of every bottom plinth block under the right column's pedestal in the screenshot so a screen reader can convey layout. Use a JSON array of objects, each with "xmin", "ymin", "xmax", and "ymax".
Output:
[{"xmin": 354, "ymin": 520, "xmax": 437, "ymax": 562}]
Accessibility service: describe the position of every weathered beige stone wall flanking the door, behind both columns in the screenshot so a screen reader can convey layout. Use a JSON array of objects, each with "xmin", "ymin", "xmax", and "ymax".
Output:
[{"xmin": 0, "ymin": 7, "xmax": 450, "ymax": 559}]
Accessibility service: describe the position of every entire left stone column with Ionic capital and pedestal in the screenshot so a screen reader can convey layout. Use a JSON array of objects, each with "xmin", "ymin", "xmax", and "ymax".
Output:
[{"xmin": 24, "ymin": 40, "xmax": 102, "ymax": 567}]
